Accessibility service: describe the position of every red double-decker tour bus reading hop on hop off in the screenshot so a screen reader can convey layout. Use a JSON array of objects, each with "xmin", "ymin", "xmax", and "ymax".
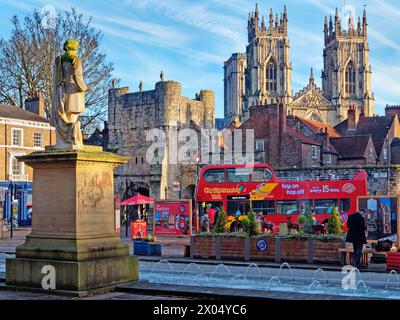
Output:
[{"xmin": 196, "ymin": 164, "xmax": 367, "ymax": 231}]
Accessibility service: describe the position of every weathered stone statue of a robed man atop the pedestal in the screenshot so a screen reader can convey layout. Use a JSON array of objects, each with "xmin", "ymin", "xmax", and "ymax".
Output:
[{"xmin": 51, "ymin": 39, "xmax": 91, "ymax": 149}]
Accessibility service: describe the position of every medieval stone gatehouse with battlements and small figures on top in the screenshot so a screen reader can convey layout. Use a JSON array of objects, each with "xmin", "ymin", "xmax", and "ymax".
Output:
[{"xmin": 108, "ymin": 81, "xmax": 215, "ymax": 198}]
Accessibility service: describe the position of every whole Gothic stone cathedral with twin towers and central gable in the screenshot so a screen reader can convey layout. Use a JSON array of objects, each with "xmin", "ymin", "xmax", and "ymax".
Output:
[{"xmin": 224, "ymin": 5, "xmax": 374, "ymax": 125}]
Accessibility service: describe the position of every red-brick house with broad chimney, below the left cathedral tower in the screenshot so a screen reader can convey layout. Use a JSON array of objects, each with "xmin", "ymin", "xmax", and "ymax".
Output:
[{"xmin": 233, "ymin": 103, "xmax": 338, "ymax": 168}]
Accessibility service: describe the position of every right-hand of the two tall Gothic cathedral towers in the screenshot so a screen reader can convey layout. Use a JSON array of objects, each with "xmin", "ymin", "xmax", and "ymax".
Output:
[{"xmin": 322, "ymin": 9, "xmax": 374, "ymax": 122}]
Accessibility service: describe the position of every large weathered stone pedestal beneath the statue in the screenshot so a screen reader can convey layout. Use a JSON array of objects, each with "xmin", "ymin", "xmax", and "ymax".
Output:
[{"xmin": 6, "ymin": 146, "xmax": 138, "ymax": 291}]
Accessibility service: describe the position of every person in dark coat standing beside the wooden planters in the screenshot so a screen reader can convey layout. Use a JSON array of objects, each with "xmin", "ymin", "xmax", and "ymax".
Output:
[{"xmin": 346, "ymin": 211, "xmax": 367, "ymax": 268}]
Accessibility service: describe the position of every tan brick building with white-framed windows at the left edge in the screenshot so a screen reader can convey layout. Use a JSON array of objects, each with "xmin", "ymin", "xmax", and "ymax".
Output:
[{"xmin": 0, "ymin": 93, "xmax": 56, "ymax": 181}]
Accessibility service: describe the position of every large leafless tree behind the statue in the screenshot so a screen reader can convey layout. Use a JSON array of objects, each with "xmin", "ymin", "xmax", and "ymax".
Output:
[{"xmin": 0, "ymin": 8, "xmax": 117, "ymax": 133}]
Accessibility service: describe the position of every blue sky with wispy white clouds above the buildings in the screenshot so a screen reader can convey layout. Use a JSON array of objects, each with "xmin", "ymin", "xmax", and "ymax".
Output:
[{"xmin": 0, "ymin": 0, "xmax": 400, "ymax": 117}]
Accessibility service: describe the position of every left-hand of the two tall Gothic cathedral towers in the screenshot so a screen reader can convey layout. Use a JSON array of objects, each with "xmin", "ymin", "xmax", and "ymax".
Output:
[{"xmin": 243, "ymin": 5, "xmax": 292, "ymax": 120}]
